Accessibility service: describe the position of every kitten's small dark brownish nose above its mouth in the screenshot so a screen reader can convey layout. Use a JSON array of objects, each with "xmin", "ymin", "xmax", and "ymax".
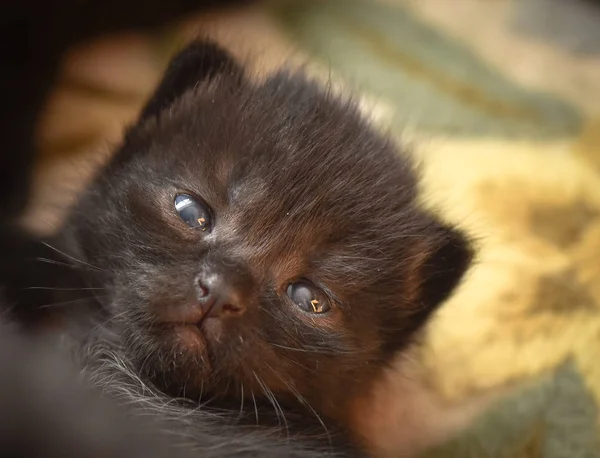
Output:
[{"xmin": 196, "ymin": 272, "xmax": 246, "ymax": 318}]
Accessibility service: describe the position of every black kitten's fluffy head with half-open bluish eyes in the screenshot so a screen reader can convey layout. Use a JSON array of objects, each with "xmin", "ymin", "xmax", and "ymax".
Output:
[{"xmin": 72, "ymin": 43, "xmax": 470, "ymax": 426}]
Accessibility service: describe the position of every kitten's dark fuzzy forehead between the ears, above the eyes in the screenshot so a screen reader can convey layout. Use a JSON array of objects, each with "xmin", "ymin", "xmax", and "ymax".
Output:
[{"xmin": 153, "ymin": 75, "xmax": 411, "ymax": 201}]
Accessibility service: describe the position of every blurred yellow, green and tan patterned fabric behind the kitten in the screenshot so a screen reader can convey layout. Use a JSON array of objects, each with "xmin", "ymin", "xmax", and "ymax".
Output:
[{"xmin": 27, "ymin": 0, "xmax": 600, "ymax": 458}]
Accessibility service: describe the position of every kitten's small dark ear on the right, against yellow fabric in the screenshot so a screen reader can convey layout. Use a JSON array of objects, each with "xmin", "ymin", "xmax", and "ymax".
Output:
[{"xmin": 408, "ymin": 223, "xmax": 473, "ymax": 311}]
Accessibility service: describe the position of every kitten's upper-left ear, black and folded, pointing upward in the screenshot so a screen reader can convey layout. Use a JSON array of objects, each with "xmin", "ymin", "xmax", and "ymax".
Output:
[{"xmin": 139, "ymin": 41, "xmax": 244, "ymax": 121}]
